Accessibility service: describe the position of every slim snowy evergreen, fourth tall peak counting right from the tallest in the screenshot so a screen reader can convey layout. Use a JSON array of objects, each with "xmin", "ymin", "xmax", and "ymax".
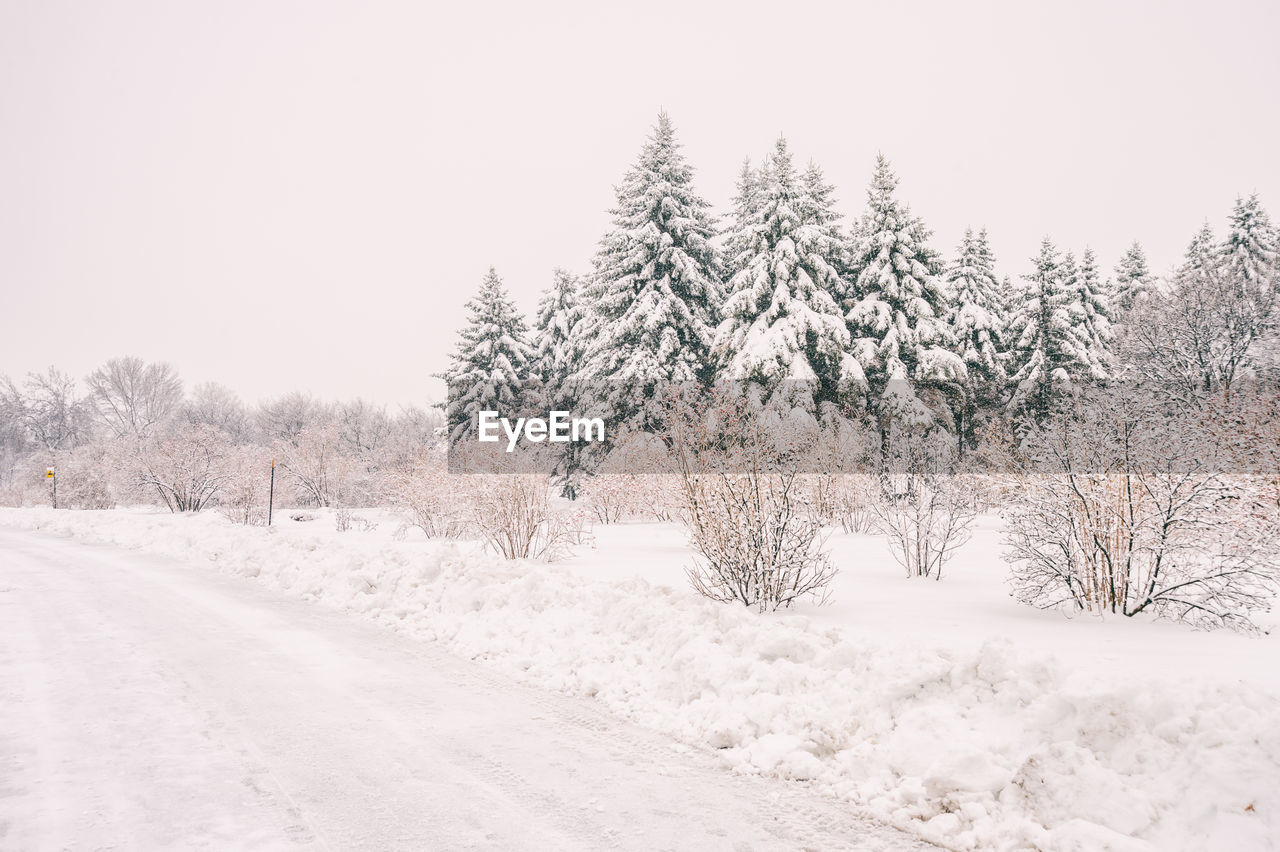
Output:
[{"xmin": 946, "ymin": 228, "xmax": 1007, "ymax": 448}]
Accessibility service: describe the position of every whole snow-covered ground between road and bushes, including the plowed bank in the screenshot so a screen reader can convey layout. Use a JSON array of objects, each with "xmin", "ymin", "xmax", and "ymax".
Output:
[{"xmin": 0, "ymin": 509, "xmax": 1280, "ymax": 851}]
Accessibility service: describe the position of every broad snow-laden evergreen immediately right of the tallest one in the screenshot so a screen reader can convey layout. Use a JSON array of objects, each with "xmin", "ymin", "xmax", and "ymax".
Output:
[{"xmin": 713, "ymin": 138, "xmax": 865, "ymax": 412}]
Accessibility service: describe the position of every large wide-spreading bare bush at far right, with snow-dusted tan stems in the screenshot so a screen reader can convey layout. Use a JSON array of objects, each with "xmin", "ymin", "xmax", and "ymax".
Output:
[{"xmin": 1005, "ymin": 400, "xmax": 1280, "ymax": 631}]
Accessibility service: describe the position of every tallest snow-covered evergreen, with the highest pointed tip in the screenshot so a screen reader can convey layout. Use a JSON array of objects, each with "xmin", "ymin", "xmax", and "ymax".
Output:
[{"xmin": 582, "ymin": 113, "xmax": 718, "ymax": 426}]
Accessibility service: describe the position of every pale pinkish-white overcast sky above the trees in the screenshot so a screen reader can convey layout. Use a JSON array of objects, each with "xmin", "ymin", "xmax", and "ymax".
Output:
[{"xmin": 0, "ymin": 0, "xmax": 1280, "ymax": 404}]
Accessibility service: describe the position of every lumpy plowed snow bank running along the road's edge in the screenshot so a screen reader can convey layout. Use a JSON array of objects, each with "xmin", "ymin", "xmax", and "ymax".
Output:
[{"xmin": 0, "ymin": 509, "xmax": 1280, "ymax": 852}]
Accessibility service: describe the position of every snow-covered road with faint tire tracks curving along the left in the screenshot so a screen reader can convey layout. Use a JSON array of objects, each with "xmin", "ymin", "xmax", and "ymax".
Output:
[{"xmin": 0, "ymin": 530, "xmax": 922, "ymax": 849}]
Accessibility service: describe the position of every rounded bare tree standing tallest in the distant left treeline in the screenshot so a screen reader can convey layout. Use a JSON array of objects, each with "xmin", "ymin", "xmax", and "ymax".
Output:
[{"xmin": 87, "ymin": 357, "xmax": 182, "ymax": 439}]
